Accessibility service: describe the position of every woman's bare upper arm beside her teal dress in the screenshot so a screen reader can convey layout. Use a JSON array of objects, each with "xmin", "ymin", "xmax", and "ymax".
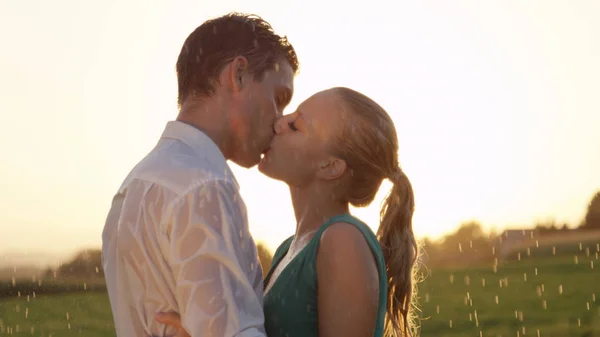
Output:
[{"xmin": 317, "ymin": 223, "xmax": 379, "ymax": 337}]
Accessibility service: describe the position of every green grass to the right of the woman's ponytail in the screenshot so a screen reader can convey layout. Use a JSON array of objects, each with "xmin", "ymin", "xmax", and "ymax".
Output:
[{"xmin": 419, "ymin": 254, "xmax": 600, "ymax": 337}]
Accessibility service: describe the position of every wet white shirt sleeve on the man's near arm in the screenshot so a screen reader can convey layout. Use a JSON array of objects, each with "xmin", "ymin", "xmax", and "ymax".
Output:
[{"xmin": 167, "ymin": 181, "xmax": 266, "ymax": 337}]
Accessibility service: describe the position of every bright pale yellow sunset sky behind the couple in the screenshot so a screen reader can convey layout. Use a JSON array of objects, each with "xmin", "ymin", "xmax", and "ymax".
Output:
[{"xmin": 0, "ymin": 0, "xmax": 600, "ymax": 254}]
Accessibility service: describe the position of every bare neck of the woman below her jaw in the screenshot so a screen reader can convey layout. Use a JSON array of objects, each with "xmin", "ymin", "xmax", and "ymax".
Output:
[{"xmin": 290, "ymin": 187, "xmax": 349, "ymax": 238}]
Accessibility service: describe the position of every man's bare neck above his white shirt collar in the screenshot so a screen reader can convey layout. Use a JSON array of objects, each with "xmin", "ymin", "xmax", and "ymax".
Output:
[{"xmin": 176, "ymin": 101, "xmax": 232, "ymax": 160}]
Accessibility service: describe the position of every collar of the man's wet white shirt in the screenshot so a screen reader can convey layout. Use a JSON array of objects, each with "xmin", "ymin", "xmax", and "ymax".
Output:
[{"xmin": 160, "ymin": 121, "xmax": 239, "ymax": 189}]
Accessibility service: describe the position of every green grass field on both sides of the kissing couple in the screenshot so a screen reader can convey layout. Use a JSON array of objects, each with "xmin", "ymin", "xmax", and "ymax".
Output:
[{"xmin": 0, "ymin": 243, "xmax": 600, "ymax": 337}]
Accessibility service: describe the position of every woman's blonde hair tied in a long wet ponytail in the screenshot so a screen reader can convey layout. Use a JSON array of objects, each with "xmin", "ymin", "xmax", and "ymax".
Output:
[{"xmin": 333, "ymin": 87, "xmax": 419, "ymax": 336}]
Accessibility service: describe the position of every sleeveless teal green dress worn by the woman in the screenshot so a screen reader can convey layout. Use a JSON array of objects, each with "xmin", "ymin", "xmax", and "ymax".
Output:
[{"xmin": 264, "ymin": 214, "xmax": 387, "ymax": 337}]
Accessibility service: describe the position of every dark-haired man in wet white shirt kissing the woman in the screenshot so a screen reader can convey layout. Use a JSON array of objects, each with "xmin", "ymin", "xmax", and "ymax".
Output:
[{"xmin": 102, "ymin": 14, "xmax": 298, "ymax": 337}]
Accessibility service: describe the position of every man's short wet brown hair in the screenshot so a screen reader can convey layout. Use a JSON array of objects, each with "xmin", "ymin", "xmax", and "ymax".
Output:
[{"xmin": 177, "ymin": 13, "xmax": 299, "ymax": 105}]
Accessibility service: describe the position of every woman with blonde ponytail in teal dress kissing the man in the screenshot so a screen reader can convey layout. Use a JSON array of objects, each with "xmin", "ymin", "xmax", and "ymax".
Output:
[{"xmin": 158, "ymin": 88, "xmax": 418, "ymax": 337}]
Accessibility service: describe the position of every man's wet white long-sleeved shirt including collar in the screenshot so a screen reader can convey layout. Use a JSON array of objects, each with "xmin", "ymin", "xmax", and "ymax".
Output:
[{"xmin": 102, "ymin": 122, "xmax": 265, "ymax": 337}]
